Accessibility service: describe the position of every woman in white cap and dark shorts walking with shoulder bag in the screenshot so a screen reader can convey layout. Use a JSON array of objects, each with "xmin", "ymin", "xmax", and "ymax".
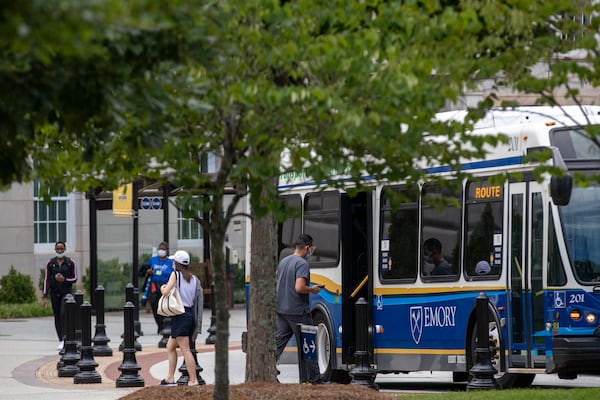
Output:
[{"xmin": 160, "ymin": 250, "xmax": 204, "ymax": 386}]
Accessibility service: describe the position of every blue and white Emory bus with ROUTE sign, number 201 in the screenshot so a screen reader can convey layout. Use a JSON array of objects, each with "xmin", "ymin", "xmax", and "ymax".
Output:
[{"xmin": 279, "ymin": 106, "xmax": 600, "ymax": 388}]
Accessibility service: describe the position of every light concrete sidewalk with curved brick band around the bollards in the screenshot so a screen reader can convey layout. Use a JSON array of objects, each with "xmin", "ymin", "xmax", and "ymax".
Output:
[{"xmin": 0, "ymin": 305, "xmax": 298, "ymax": 400}]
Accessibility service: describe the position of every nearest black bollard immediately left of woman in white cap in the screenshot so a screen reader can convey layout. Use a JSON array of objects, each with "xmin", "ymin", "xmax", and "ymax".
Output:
[{"xmin": 115, "ymin": 301, "xmax": 144, "ymax": 387}]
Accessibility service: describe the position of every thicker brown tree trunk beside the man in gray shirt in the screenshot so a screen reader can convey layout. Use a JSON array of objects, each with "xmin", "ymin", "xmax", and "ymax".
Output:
[{"xmin": 246, "ymin": 191, "xmax": 277, "ymax": 382}]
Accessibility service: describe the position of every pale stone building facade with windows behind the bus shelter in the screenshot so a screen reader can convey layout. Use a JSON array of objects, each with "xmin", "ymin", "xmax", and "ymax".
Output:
[{"xmin": 0, "ymin": 183, "xmax": 247, "ymax": 295}]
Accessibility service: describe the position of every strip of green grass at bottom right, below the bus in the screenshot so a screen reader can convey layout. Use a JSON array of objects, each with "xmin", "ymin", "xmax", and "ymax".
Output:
[{"xmin": 398, "ymin": 388, "xmax": 600, "ymax": 400}]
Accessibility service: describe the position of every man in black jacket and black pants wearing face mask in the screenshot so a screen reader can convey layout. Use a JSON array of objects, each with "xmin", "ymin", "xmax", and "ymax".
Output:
[{"xmin": 43, "ymin": 242, "xmax": 77, "ymax": 350}]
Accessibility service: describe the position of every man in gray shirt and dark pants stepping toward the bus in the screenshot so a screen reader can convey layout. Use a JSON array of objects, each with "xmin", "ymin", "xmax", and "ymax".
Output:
[{"xmin": 276, "ymin": 234, "xmax": 322, "ymax": 384}]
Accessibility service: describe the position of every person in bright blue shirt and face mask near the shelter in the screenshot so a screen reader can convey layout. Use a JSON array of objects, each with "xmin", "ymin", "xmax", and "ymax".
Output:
[{"xmin": 142, "ymin": 242, "xmax": 174, "ymax": 334}]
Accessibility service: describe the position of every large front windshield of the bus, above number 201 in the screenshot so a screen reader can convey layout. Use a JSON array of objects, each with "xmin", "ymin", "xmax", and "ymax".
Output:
[{"xmin": 560, "ymin": 184, "xmax": 600, "ymax": 283}]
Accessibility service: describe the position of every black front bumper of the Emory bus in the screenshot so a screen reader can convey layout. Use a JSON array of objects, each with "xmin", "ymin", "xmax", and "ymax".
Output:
[{"xmin": 552, "ymin": 336, "xmax": 600, "ymax": 379}]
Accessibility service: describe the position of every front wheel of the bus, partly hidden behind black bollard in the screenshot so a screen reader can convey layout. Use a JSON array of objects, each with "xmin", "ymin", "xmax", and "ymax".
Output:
[{"xmin": 467, "ymin": 311, "xmax": 518, "ymax": 389}]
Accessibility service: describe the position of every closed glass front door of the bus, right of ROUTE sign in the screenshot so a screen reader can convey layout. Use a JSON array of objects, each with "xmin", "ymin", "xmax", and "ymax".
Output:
[{"xmin": 508, "ymin": 182, "xmax": 548, "ymax": 368}]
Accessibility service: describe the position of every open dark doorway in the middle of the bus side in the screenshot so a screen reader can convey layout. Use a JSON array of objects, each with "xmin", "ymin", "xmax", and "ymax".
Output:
[{"xmin": 341, "ymin": 191, "xmax": 373, "ymax": 364}]
